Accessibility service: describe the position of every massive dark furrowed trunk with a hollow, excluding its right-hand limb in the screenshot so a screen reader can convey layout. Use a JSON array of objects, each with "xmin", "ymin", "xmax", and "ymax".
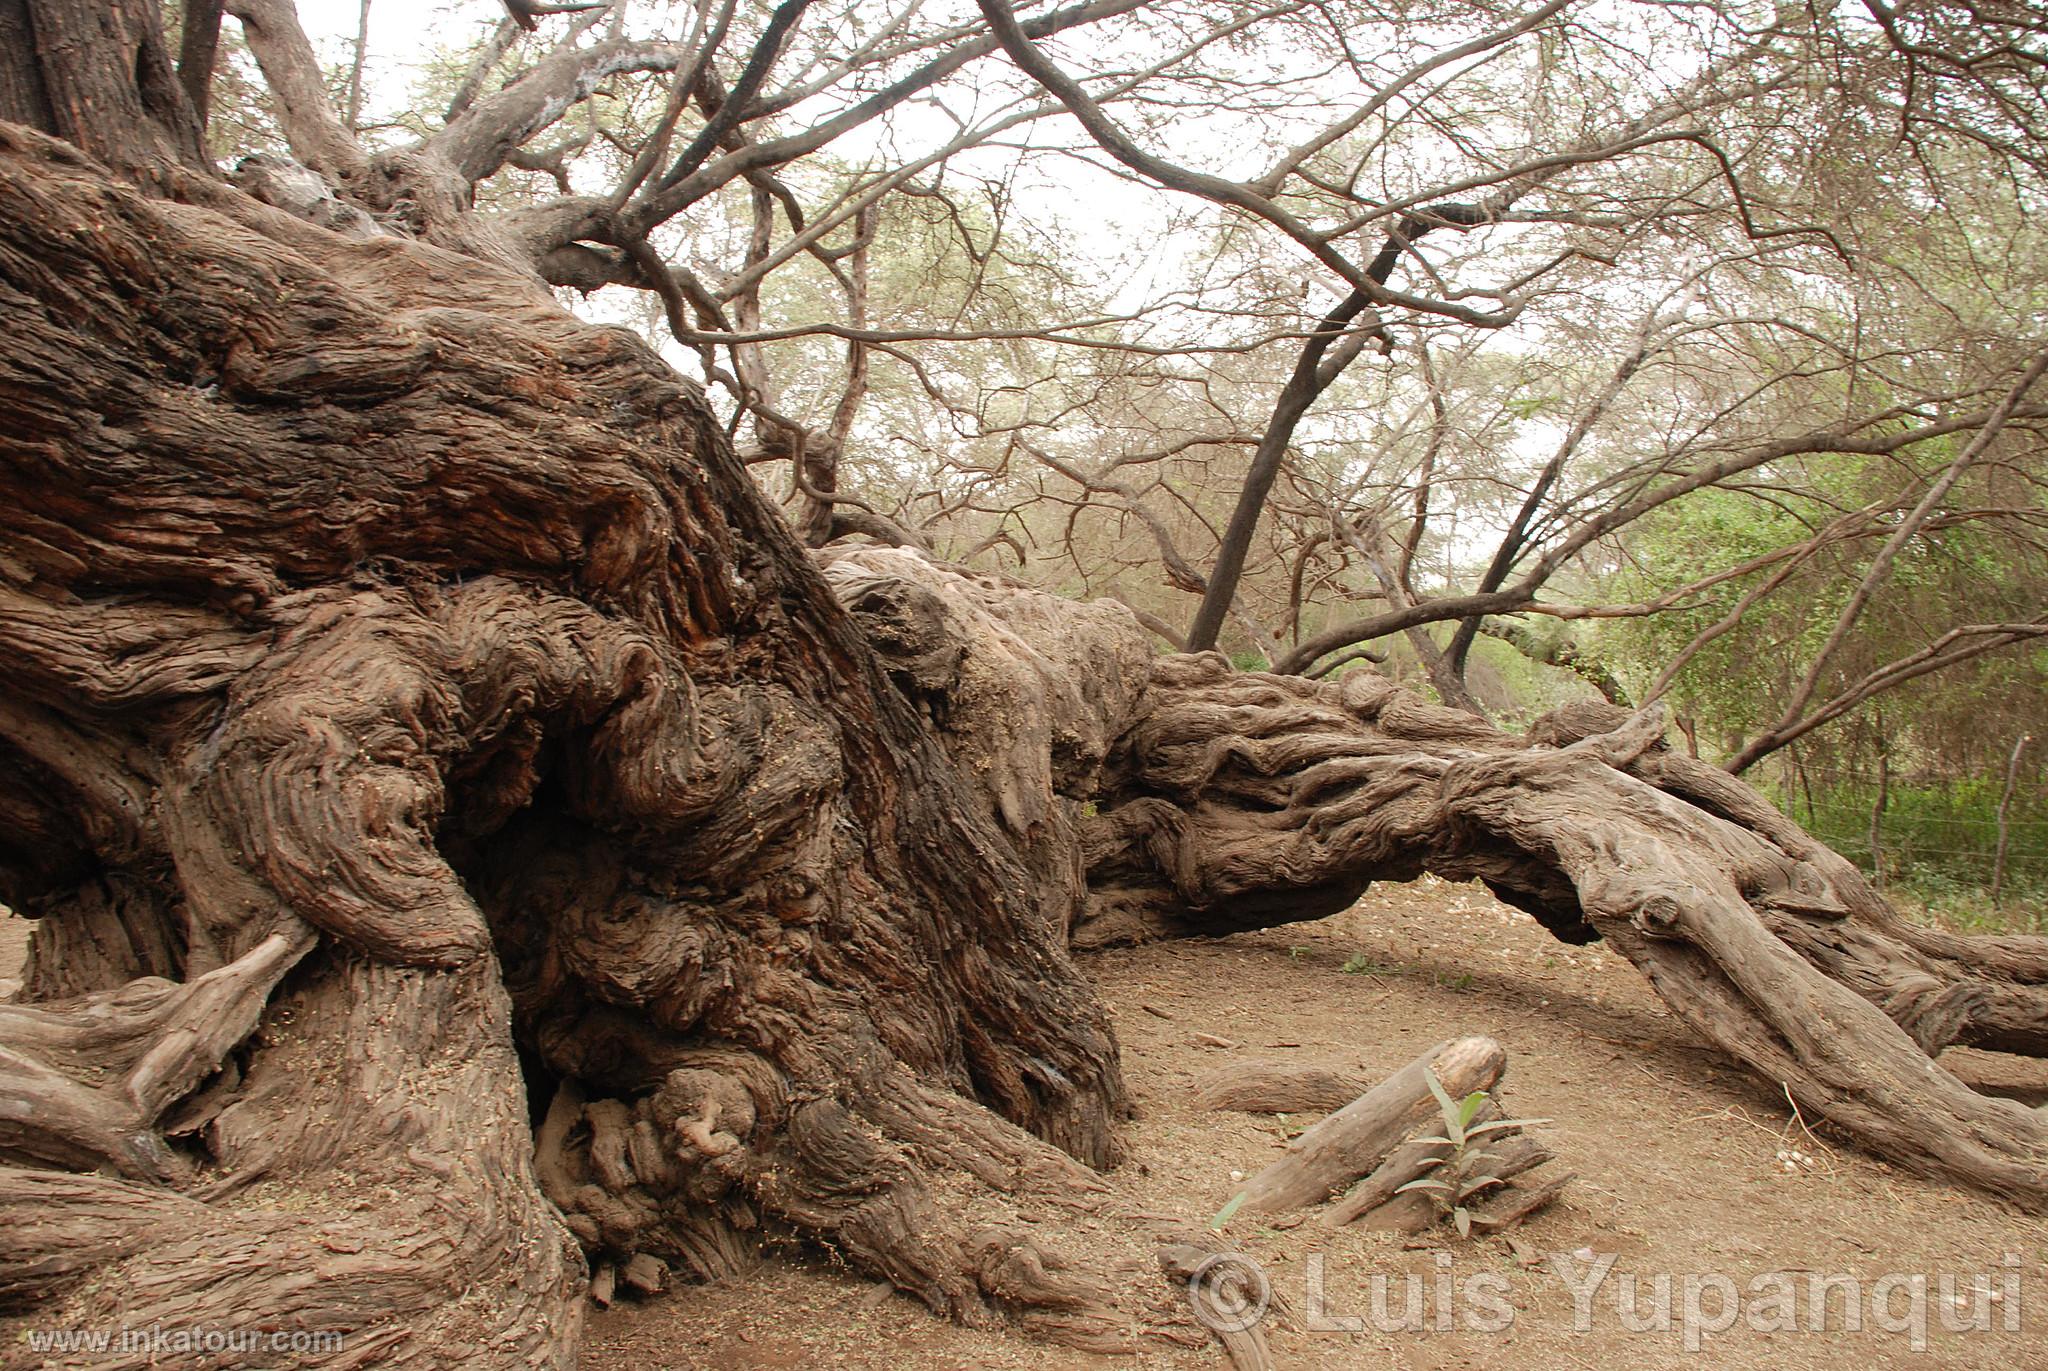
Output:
[{"xmin": 0, "ymin": 125, "xmax": 1145, "ymax": 1367}]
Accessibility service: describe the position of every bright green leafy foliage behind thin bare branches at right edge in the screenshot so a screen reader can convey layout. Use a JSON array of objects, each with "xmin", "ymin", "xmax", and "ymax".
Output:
[{"xmin": 1604, "ymin": 457, "xmax": 2048, "ymax": 908}]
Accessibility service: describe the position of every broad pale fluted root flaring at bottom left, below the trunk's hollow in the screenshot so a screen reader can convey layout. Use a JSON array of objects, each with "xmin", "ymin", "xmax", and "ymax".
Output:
[{"xmin": 0, "ymin": 953, "xmax": 582, "ymax": 1367}]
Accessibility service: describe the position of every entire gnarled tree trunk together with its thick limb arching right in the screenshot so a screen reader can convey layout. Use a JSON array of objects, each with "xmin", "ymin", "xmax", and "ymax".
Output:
[{"xmin": 0, "ymin": 8, "xmax": 2048, "ymax": 1367}]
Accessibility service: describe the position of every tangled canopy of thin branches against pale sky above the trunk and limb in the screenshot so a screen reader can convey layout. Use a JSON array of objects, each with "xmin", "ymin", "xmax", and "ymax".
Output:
[{"xmin": 167, "ymin": 0, "xmax": 2048, "ymax": 766}]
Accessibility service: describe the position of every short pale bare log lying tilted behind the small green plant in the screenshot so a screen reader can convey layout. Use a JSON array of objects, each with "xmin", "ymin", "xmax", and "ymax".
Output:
[{"xmin": 1241, "ymin": 1037, "xmax": 1507, "ymax": 1213}]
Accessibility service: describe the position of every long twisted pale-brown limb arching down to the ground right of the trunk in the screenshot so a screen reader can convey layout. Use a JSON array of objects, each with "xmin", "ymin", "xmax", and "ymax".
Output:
[{"xmin": 1073, "ymin": 668, "xmax": 2048, "ymax": 1209}]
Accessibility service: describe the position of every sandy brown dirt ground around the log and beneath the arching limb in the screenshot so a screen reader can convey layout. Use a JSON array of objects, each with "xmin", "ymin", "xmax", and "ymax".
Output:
[{"xmin": 0, "ymin": 879, "xmax": 2048, "ymax": 1371}]
